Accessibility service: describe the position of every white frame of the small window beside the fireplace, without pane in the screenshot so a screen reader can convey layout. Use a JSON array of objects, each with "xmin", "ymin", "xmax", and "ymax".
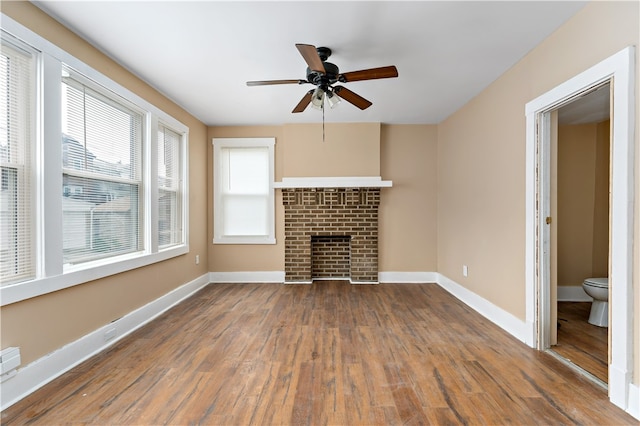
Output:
[{"xmin": 211, "ymin": 137, "xmax": 276, "ymax": 244}]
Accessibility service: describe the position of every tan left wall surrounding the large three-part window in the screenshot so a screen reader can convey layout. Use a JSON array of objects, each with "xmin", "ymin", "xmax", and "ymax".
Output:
[{"xmin": 0, "ymin": 2, "xmax": 208, "ymax": 365}]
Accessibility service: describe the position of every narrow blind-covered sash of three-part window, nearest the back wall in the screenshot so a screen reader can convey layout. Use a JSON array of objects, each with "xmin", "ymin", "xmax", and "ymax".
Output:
[{"xmin": 157, "ymin": 124, "xmax": 184, "ymax": 249}]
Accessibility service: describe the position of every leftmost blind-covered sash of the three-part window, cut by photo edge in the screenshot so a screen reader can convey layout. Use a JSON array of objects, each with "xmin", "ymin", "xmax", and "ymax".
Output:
[{"xmin": 0, "ymin": 34, "xmax": 36, "ymax": 284}]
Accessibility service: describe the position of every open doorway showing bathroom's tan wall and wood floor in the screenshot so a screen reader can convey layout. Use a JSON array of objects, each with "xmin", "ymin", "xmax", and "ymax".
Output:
[{"xmin": 548, "ymin": 81, "xmax": 611, "ymax": 387}]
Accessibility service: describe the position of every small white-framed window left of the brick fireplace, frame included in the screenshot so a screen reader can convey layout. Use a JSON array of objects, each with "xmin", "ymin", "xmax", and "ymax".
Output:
[{"xmin": 213, "ymin": 138, "xmax": 275, "ymax": 244}]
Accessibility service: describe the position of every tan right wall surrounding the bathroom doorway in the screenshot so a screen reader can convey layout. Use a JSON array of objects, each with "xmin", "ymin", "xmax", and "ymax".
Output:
[{"xmin": 438, "ymin": 2, "xmax": 640, "ymax": 376}]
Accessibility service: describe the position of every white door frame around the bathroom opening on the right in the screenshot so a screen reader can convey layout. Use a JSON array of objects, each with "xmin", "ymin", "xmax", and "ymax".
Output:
[{"xmin": 525, "ymin": 46, "xmax": 635, "ymax": 410}]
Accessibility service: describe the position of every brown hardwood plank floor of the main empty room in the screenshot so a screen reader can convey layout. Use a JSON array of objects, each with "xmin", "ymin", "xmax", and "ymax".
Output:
[{"xmin": 2, "ymin": 281, "xmax": 638, "ymax": 425}]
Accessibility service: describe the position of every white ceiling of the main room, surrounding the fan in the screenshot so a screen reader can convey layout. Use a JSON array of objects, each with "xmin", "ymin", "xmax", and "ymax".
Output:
[{"xmin": 34, "ymin": 1, "xmax": 587, "ymax": 125}]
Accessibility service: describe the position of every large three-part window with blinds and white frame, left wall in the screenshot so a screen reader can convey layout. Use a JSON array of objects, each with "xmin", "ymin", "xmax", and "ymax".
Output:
[{"xmin": 0, "ymin": 15, "xmax": 189, "ymax": 305}]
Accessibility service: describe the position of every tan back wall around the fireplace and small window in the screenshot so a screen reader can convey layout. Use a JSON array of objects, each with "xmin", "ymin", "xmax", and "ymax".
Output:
[{"xmin": 207, "ymin": 123, "xmax": 436, "ymax": 272}]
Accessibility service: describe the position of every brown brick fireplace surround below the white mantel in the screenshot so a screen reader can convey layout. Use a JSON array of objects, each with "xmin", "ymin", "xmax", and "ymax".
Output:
[{"xmin": 282, "ymin": 188, "xmax": 380, "ymax": 283}]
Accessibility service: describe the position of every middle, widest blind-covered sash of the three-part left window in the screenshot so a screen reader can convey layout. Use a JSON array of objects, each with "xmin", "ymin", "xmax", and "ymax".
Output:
[{"xmin": 62, "ymin": 70, "xmax": 144, "ymax": 264}]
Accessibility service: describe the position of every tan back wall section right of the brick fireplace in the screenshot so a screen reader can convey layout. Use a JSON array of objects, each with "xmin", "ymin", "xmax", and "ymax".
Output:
[{"xmin": 378, "ymin": 124, "xmax": 438, "ymax": 272}]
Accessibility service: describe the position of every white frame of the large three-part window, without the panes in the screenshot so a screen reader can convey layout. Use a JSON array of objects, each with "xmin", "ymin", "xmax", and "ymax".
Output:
[{"xmin": 0, "ymin": 14, "xmax": 189, "ymax": 306}]
